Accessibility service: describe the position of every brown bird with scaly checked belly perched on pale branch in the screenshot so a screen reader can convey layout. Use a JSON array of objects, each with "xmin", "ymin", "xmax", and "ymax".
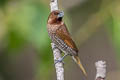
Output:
[{"xmin": 47, "ymin": 10, "xmax": 87, "ymax": 76}]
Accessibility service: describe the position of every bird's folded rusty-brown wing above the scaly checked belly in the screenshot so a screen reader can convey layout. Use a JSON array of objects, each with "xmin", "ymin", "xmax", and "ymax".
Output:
[{"xmin": 56, "ymin": 24, "xmax": 78, "ymax": 52}]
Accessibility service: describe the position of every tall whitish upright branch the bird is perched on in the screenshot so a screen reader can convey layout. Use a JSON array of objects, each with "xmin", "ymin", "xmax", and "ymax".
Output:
[{"xmin": 50, "ymin": 0, "xmax": 64, "ymax": 80}]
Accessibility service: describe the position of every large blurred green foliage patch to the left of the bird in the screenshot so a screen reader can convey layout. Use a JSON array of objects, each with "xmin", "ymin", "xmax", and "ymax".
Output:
[{"xmin": 0, "ymin": 0, "xmax": 52, "ymax": 80}]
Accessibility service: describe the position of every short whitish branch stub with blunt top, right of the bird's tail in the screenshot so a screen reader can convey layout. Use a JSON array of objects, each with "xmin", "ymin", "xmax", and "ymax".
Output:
[{"xmin": 95, "ymin": 61, "xmax": 106, "ymax": 80}]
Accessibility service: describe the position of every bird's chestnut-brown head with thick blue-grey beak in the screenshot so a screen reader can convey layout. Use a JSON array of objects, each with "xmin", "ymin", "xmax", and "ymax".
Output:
[{"xmin": 48, "ymin": 10, "xmax": 64, "ymax": 23}]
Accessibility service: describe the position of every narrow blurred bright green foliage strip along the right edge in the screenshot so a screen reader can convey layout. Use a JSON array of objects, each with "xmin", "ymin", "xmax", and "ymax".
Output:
[{"xmin": 111, "ymin": 0, "xmax": 120, "ymax": 60}]
